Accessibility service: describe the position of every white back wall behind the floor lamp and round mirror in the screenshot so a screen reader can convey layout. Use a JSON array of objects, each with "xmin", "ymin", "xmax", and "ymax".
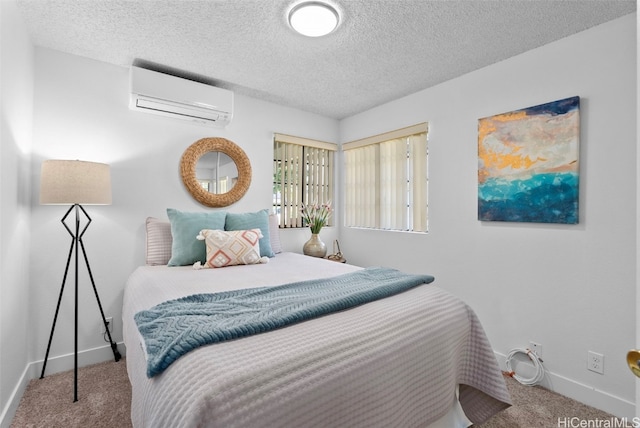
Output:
[{"xmin": 30, "ymin": 48, "xmax": 338, "ymax": 372}]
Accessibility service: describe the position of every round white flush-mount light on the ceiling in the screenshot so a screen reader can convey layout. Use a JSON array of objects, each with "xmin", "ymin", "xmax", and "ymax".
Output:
[{"xmin": 289, "ymin": 1, "xmax": 340, "ymax": 37}]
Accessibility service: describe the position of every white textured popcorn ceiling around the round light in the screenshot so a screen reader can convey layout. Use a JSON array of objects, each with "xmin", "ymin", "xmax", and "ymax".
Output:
[{"xmin": 13, "ymin": 0, "xmax": 636, "ymax": 119}]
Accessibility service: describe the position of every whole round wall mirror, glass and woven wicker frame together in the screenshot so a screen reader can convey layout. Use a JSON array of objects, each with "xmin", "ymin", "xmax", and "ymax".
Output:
[{"xmin": 180, "ymin": 138, "xmax": 251, "ymax": 207}]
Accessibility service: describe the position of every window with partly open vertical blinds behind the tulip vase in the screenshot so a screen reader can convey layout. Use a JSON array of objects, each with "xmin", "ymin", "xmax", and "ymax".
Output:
[{"xmin": 273, "ymin": 134, "xmax": 337, "ymax": 228}]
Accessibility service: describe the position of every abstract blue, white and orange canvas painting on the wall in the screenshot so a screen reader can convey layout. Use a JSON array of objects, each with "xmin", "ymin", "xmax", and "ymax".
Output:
[{"xmin": 478, "ymin": 97, "xmax": 580, "ymax": 224}]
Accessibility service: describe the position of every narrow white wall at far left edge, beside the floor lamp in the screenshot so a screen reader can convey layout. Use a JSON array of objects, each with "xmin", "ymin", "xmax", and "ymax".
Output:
[{"xmin": 0, "ymin": 1, "xmax": 33, "ymax": 426}]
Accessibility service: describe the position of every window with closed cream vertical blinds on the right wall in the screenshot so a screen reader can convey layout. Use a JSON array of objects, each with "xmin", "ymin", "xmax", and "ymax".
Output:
[{"xmin": 342, "ymin": 123, "xmax": 428, "ymax": 232}]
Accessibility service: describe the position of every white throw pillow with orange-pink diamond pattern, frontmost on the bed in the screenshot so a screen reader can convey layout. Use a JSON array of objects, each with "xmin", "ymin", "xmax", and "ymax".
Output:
[{"xmin": 197, "ymin": 229, "xmax": 269, "ymax": 268}]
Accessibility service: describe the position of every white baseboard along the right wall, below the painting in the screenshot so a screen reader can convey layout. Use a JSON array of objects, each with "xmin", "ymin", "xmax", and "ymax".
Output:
[{"xmin": 494, "ymin": 352, "xmax": 636, "ymax": 420}]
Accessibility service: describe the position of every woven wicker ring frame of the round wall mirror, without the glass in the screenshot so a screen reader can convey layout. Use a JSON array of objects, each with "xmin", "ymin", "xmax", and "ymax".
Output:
[{"xmin": 180, "ymin": 138, "xmax": 251, "ymax": 207}]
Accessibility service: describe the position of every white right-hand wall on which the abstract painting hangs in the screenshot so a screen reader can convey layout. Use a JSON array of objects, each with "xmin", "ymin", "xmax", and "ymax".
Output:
[{"xmin": 340, "ymin": 14, "xmax": 638, "ymax": 416}]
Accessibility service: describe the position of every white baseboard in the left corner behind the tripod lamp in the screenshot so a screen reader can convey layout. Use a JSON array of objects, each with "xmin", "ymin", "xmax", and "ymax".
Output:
[{"xmin": 0, "ymin": 343, "xmax": 126, "ymax": 428}]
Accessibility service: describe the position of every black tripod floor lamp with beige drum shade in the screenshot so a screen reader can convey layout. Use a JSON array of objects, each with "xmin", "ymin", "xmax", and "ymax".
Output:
[{"xmin": 40, "ymin": 160, "xmax": 121, "ymax": 402}]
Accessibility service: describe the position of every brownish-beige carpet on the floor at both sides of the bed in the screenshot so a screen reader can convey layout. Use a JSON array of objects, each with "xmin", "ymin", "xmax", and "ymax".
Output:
[{"xmin": 11, "ymin": 359, "xmax": 622, "ymax": 428}]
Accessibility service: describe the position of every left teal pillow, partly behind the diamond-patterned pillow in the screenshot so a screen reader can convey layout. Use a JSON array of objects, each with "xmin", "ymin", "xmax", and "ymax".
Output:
[{"xmin": 167, "ymin": 208, "xmax": 227, "ymax": 266}]
